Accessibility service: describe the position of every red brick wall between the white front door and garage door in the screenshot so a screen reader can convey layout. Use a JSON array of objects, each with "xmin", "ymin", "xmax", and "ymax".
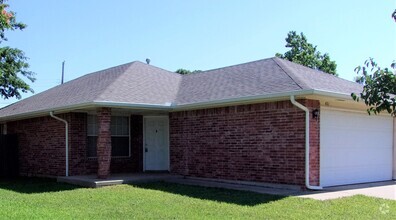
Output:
[{"xmin": 170, "ymin": 100, "xmax": 319, "ymax": 185}]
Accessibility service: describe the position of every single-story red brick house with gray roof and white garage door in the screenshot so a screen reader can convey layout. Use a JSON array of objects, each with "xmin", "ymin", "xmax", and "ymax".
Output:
[{"xmin": 0, "ymin": 58, "xmax": 396, "ymax": 188}]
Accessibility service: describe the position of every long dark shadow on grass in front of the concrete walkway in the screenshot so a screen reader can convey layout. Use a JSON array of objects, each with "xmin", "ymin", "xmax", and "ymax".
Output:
[{"xmin": 130, "ymin": 182, "xmax": 286, "ymax": 206}]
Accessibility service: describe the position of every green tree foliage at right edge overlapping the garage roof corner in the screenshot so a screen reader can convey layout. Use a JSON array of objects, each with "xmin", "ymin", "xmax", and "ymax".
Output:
[{"xmin": 351, "ymin": 10, "xmax": 396, "ymax": 117}]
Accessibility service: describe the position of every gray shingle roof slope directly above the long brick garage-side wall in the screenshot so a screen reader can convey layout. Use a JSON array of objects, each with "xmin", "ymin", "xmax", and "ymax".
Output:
[{"xmin": 176, "ymin": 59, "xmax": 301, "ymax": 104}]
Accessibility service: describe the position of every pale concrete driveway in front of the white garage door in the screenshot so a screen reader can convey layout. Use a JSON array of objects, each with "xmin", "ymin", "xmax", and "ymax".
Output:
[{"xmin": 298, "ymin": 181, "xmax": 396, "ymax": 200}]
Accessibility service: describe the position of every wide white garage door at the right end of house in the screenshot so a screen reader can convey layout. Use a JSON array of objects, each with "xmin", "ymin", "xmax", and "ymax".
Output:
[{"xmin": 320, "ymin": 108, "xmax": 393, "ymax": 186}]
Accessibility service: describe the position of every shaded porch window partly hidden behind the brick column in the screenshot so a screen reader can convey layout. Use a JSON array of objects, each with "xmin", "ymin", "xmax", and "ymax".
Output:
[{"xmin": 87, "ymin": 115, "xmax": 130, "ymax": 157}]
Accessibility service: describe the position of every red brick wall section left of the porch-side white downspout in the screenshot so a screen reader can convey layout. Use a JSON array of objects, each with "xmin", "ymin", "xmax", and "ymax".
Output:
[{"xmin": 7, "ymin": 115, "xmax": 70, "ymax": 176}]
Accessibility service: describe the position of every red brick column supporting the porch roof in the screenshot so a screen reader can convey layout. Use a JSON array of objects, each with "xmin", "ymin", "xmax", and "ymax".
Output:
[{"xmin": 96, "ymin": 108, "xmax": 111, "ymax": 179}]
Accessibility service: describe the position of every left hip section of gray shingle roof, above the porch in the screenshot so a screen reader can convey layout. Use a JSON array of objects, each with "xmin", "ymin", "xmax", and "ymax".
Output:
[{"xmin": 0, "ymin": 62, "xmax": 181, "ymax": 117}]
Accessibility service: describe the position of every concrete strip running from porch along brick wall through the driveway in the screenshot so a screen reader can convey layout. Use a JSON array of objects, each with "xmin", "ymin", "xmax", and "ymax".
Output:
[{"xmin": 58, "ymin": 173, "xmax": 396, "ymax": 200}]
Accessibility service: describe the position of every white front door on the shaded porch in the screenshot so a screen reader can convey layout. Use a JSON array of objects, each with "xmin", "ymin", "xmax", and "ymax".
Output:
[{"xmin": 143, "ymin": 116, "xmax": 169, "ymax": 171}]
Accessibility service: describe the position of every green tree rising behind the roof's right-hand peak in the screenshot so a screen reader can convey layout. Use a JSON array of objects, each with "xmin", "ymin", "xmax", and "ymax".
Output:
[{"xmin": 275, "ymin": 31, "xmax": 337, "ymax": 75}]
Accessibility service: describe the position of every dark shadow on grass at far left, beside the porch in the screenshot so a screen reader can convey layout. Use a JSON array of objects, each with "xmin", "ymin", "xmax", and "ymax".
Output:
[{"xmin": 0, "ymin": 177, "xmax": 79, "ymax": 194}]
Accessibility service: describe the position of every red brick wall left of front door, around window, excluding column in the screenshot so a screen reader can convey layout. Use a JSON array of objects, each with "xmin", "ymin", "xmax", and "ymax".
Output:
[{"xmin": 7, "ymin": 113, "xmax": 143, "ymax": 176}]
